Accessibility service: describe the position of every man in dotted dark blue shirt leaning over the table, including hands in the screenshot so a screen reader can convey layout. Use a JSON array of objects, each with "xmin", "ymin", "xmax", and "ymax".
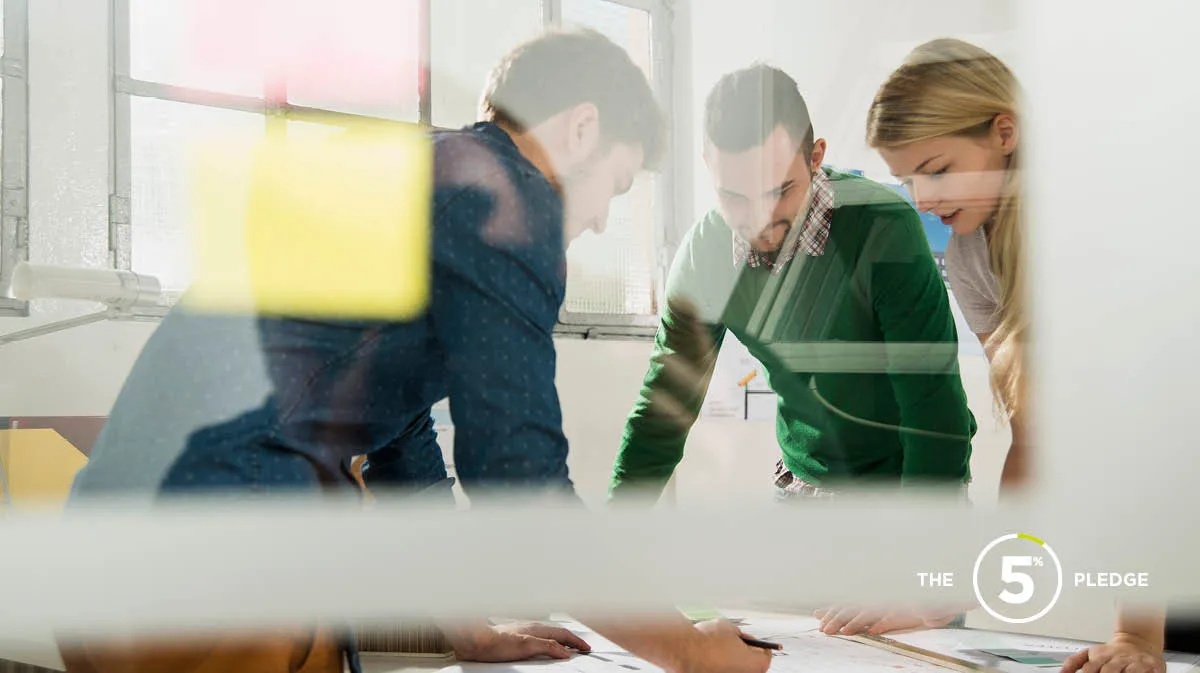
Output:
[{"xmin": 62, "ymin": 31, "xmax": 770, "ymax": 673}]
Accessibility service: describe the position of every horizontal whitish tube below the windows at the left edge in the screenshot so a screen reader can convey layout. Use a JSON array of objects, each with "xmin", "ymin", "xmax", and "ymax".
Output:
[{"xmin": 12, "ymin": 263, "xmax": 162, "ymax": 308}]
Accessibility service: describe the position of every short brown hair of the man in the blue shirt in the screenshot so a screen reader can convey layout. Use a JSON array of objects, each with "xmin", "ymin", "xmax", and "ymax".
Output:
[{"xmin": 480, "ymin": 30, "xmax": 666, "ymax": 168}]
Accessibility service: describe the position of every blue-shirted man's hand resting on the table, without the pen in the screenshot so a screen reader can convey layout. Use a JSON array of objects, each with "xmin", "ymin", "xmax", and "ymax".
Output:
[{"xmin": 442, "ymin": 623, "xmax": 592, "ymax": 663}]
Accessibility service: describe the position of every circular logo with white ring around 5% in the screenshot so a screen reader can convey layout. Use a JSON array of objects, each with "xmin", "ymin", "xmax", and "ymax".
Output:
[{"xmin": 971, "ymin": 533, "xmax": 1062, "ymax": 624}]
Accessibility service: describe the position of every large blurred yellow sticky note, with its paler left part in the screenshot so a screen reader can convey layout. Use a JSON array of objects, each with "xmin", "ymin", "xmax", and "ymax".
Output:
[{"xmin": 187, "ymin": 124, "xmax": 433, "ymax": 320}]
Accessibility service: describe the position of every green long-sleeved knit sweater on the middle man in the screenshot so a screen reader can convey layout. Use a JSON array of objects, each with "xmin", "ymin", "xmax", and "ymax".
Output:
[{"xmin": 610, "ymin": 170, "xmax": 976, "ymax": 499}]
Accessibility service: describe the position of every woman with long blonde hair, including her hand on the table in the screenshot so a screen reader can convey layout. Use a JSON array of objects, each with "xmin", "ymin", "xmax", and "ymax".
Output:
[{"xmin": 866, "ymin": 40, "xmax": 1165, "ymax": 673}]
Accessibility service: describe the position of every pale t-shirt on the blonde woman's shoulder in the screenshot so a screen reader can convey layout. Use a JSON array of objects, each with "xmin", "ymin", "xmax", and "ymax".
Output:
[{"xmin": 946, "ymin": 227, "xmax": 1000, "ymax": 335}]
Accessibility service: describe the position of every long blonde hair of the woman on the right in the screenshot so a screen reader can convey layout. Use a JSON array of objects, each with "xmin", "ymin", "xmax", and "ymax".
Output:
[{"xmin": 866, "ymin": 38, "xmax": 1028, "ymax": 417}]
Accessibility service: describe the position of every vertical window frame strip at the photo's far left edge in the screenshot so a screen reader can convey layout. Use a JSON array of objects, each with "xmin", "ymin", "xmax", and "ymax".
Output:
[{"xmin": 0, "ymin": 0, "xmax": 29, "ymax": 317}]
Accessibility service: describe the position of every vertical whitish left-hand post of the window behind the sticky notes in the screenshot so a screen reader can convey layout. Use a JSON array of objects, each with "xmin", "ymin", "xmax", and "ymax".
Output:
[{"xmin": 108, "ymin": 0, "xmax": 133, "ymax": 270}]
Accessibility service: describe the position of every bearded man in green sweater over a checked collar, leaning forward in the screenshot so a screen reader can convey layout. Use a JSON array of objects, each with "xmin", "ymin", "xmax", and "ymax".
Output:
[{"xmin": 610, "ymin": 66, "xmax": 976, "ymax": 501}]
